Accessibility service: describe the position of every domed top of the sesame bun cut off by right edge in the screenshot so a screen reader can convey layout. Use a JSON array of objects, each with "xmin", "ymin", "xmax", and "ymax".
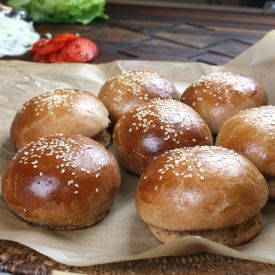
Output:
[{"xmin": 216, "ymin": 106, "xmax": 275, "ymax": 176}]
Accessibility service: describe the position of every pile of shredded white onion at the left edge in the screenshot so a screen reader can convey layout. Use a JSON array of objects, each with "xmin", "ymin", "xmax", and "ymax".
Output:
[{"xmin": 0, "ymin": 16, "xmax": 40, "ymax": 58}]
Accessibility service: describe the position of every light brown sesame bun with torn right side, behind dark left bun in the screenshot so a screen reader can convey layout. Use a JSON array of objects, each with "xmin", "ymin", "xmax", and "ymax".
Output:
[{"xmin": 10, "ymin": 88, "xmax": 110, "ymax": 150}]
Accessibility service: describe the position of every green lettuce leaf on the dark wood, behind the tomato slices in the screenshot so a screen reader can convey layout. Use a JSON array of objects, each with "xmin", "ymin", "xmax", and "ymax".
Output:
[{"xmin": 7, "ymin": 0, "xmax": 108, "ymax": 25}]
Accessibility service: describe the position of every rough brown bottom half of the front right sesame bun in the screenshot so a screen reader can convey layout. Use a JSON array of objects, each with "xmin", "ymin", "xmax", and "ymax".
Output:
[{"xmin": 148, "ymin": 212, "xmax": 262, "ymax": 247}]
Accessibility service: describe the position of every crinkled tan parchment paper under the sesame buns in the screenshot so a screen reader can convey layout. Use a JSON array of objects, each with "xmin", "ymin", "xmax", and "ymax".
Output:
[{"xmin": 0, "ymin": 31, "xmax": 275, "ymax": 266}]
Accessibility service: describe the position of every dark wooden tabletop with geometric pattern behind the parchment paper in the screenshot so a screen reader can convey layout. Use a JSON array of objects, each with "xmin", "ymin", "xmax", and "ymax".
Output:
[{"xmin": 3, "ymin": 4, "xmax": 275, "ymax": 65}]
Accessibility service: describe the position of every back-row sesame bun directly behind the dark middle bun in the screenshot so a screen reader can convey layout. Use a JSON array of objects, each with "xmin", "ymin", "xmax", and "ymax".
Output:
[{"xmin": 98, "ymin": 70, "xmax": 179, "ymax": 125}]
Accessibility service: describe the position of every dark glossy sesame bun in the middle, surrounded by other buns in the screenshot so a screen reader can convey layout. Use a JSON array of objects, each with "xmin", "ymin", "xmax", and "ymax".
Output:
[{"xmin": 113, "ymin": 99, "xmax": 213, "ymax": 175}]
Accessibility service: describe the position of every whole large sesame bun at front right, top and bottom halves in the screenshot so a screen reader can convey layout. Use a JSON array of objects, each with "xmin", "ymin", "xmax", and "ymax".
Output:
[{"xmin": 135, "ymin": 146, "xmax": 268, "ymax": 247}]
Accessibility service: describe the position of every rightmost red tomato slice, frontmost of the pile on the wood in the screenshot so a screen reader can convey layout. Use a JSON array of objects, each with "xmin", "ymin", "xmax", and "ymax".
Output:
[{"xmin": 67, "ymin": 38, "xmax": 98, "ymax": 62}]
